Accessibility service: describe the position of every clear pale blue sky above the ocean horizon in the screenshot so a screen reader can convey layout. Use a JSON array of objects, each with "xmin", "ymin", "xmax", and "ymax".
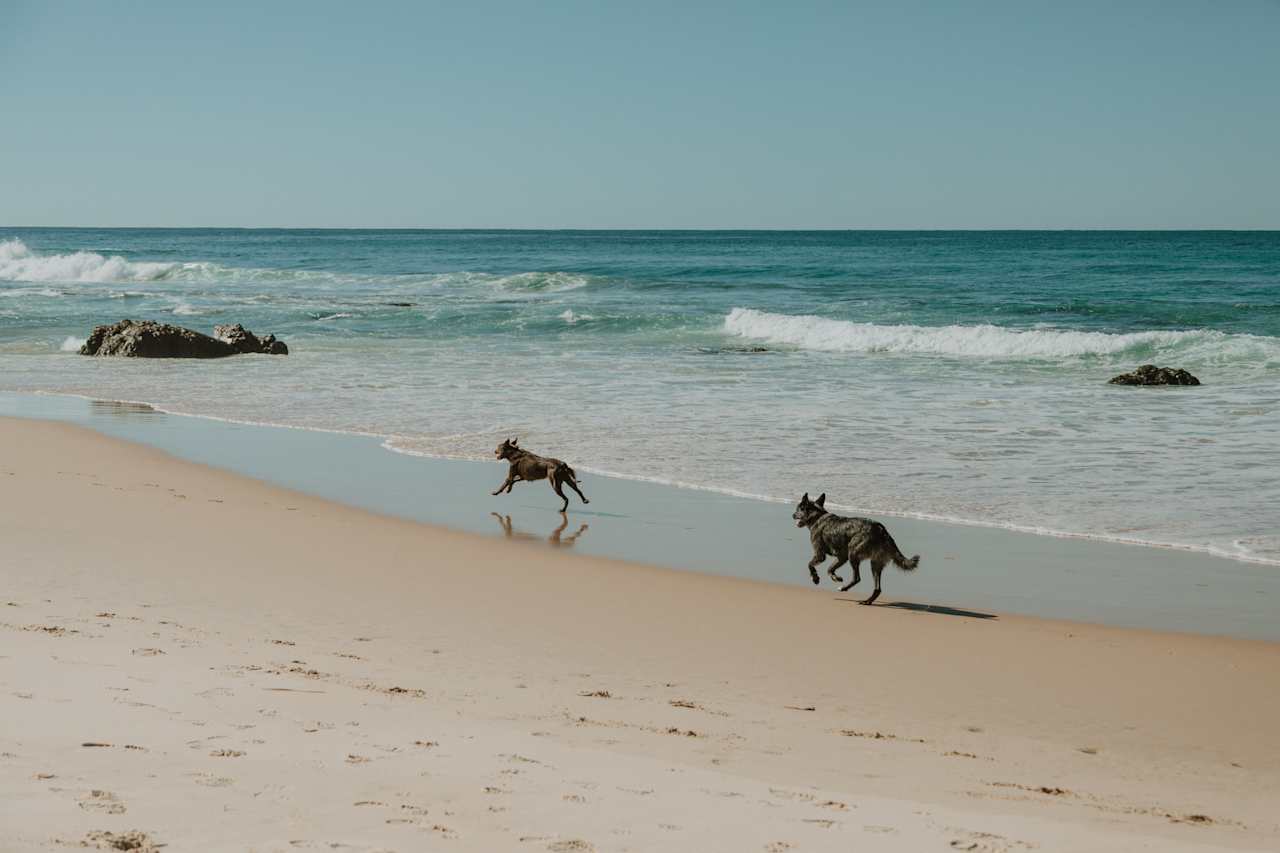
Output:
[{"xmin": 0, "ymin": 0, "xmax": 1280, "ymax": 228}]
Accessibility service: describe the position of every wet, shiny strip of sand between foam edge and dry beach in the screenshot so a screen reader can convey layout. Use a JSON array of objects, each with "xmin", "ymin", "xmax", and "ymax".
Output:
[{"xmin": 0, "ymin": 393, "xmax": 1280, "ymax": 640}]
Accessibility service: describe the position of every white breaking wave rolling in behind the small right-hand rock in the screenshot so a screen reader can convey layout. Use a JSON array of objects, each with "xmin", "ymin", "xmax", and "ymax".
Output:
[{"xmin": 724, "ymin": 307, "xmax": 1280, "ymax": 360}]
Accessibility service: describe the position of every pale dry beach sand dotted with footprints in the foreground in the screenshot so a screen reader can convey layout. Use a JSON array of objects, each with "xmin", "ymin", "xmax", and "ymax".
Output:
[{"xmin": 0, "ymin": 420, "xmax": 1280, "ymax": 853}]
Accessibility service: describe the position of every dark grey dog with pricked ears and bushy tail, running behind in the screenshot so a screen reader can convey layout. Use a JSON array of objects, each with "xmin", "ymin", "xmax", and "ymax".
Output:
[{"xmin": 791, "ymin": 492, "xmax": 920, "ymax": 605}]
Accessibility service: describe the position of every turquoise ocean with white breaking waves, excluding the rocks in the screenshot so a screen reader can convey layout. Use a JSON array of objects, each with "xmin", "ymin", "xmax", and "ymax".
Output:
[{"xmin": 0, "ymin": 228, "xmax": 1280, "ymax": 565}]
